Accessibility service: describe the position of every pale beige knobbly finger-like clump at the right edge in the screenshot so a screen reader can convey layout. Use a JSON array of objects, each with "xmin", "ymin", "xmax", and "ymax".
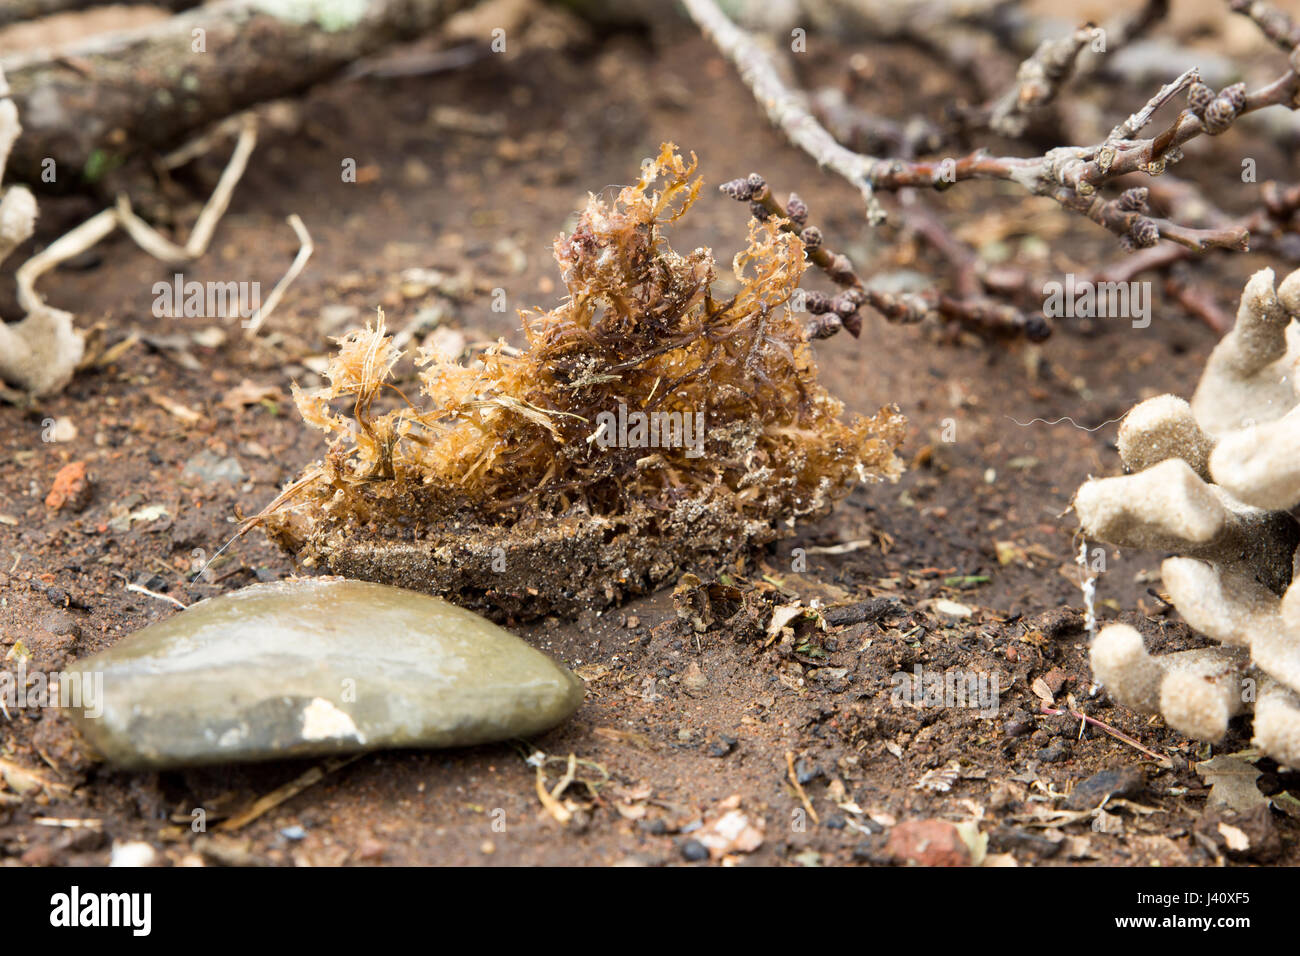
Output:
[{"xmin": 1075, "ymin": 269, "xmax": 1300, "ymax": 767}]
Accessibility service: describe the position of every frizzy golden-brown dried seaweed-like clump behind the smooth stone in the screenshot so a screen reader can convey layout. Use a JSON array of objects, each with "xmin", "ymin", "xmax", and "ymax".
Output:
[{"xmin": 265, "ymin": 144, "xmax": 904, "ymax": 617}]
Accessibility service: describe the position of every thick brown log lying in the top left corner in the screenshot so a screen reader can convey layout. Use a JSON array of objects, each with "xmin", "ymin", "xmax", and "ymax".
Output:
[{"xmin": 0, "ymin": 0, "xmax": 469, "ymax": 183}]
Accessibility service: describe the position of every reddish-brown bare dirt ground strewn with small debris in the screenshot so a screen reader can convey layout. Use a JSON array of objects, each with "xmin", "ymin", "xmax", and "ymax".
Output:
[{"xmin": 0, "ymin": 14, "xmax": 1300, "ymax": 865}]
